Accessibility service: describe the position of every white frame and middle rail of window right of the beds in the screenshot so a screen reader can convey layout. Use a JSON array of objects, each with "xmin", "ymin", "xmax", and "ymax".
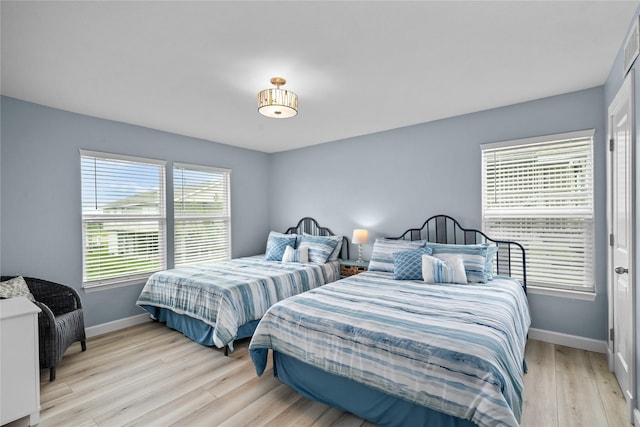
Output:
[{"xmin": 481, "ymin": 129, "xmax": 596, "ymax": 299}]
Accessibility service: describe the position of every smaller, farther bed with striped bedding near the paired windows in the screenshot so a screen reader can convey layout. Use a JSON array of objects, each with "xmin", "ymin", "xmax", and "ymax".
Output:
[{"xmin": 136, "ymin": 217, "xmax": 349, "ymax": 354}]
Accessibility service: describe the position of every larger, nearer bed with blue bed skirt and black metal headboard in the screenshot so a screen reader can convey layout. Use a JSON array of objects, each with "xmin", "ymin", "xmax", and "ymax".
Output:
[{"xmin": 249, "ymin": 215, "xmax": 530, "ymax": 427}]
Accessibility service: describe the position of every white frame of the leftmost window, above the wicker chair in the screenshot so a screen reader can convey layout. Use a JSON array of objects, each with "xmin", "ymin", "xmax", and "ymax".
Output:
[{"xmin": 80, "ymin": 149, "xmax": 168, "ymax": 291}]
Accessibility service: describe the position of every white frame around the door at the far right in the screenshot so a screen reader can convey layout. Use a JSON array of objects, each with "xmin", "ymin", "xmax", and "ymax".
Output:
[{"xmin": 606, "ymin": 71, "xmax": 637, "ymax": 424}]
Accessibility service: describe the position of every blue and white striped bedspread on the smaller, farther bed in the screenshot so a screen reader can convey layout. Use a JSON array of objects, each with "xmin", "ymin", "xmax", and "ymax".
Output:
[{"xmin": 136, "ymin": 255, "xmax": 340, "ymax": 347}]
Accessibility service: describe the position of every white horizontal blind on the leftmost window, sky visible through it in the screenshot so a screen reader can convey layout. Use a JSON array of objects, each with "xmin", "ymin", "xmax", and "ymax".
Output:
[{"xmin": 81, "ymin": 150, "xmax": 166, "ymax": 288}]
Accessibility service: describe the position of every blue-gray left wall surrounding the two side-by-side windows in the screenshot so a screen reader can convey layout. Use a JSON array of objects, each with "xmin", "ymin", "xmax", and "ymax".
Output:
[{"xmin": 0, "ymin": 97, "xmax": 269, "ymax": 326}]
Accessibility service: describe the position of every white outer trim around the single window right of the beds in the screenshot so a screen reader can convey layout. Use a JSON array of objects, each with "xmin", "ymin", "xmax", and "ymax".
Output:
[{"xmin": 480, "ymin": 129, "xmax": 596, "ymax": 301}]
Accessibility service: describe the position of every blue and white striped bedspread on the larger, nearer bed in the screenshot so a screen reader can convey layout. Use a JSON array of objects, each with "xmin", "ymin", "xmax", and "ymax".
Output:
[{"xmin": 249, "ymin": 272, "xmax": 530, "ymax": 426}]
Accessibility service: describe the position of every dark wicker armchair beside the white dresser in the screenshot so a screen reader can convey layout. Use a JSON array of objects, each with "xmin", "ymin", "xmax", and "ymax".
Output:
[{"xmin": 0, "ymin": 276, "xmax": 87, "ymax": 381}]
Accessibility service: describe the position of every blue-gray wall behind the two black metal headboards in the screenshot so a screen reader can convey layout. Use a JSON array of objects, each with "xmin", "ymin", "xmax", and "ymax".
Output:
[{"xmin": 269, "ymin": 86, "xmax": 607, "ymax": 340}]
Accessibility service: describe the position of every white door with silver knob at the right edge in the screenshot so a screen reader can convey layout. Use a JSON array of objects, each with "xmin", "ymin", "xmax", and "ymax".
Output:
[{"xmin": 609, "ymin": 73, "xmax": 635, "ymax": 420}]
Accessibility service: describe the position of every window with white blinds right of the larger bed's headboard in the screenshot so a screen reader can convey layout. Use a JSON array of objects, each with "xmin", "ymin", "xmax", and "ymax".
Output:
[{"xmin": 482, "ymin": 130, "xmax": 594, "ymax": 292}]
